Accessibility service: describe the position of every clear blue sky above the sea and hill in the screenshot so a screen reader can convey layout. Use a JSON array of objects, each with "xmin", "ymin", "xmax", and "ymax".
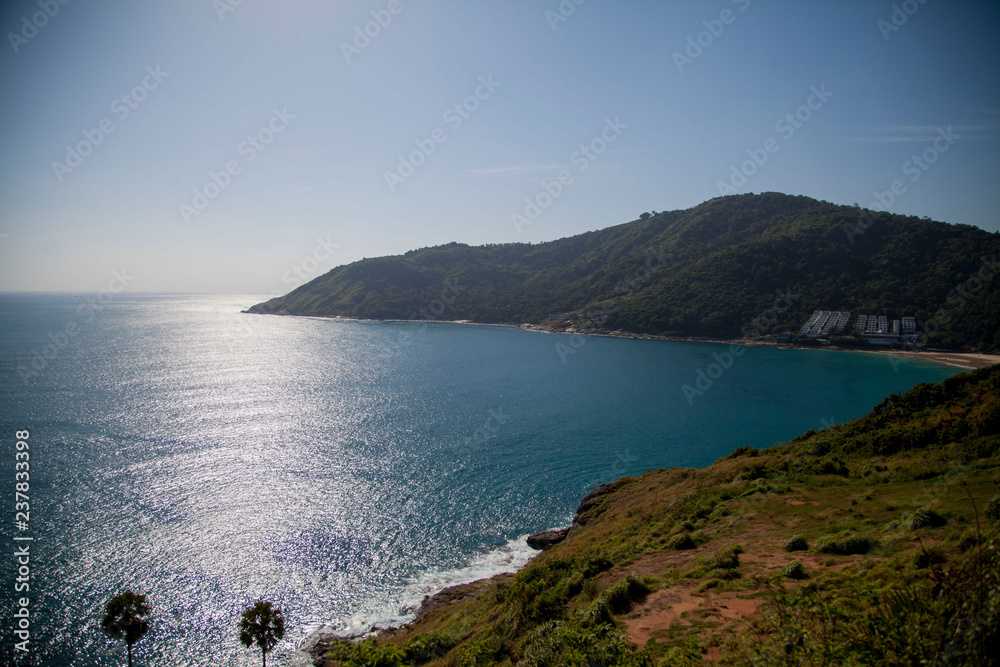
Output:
[{"xmin": 0, "ymin": 0, "xmax": 1000, "ymax": 294}]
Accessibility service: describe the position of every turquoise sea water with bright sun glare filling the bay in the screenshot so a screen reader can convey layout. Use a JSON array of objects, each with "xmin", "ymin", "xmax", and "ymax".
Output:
[{"xmin": 0, "ymin": 294, "xmax": 957, "ymax": 667}]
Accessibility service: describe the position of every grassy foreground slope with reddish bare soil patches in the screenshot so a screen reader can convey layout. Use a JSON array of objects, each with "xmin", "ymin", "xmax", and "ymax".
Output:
[{"xmin": 318, "ymin": 367, "xmax": 1000, "ymax": 665}]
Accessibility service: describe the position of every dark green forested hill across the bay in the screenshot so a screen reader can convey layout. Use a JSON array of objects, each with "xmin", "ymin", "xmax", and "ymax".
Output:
[{"xmin": 250, "ymin": 193, "xmax": 1000, "ymax": 351}]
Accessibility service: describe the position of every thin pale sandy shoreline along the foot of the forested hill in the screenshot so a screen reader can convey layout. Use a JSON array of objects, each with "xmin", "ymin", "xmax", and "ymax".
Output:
[{"xmin": 240, "ymin": 310, "xmax": 1000, "ymax": 371}]
